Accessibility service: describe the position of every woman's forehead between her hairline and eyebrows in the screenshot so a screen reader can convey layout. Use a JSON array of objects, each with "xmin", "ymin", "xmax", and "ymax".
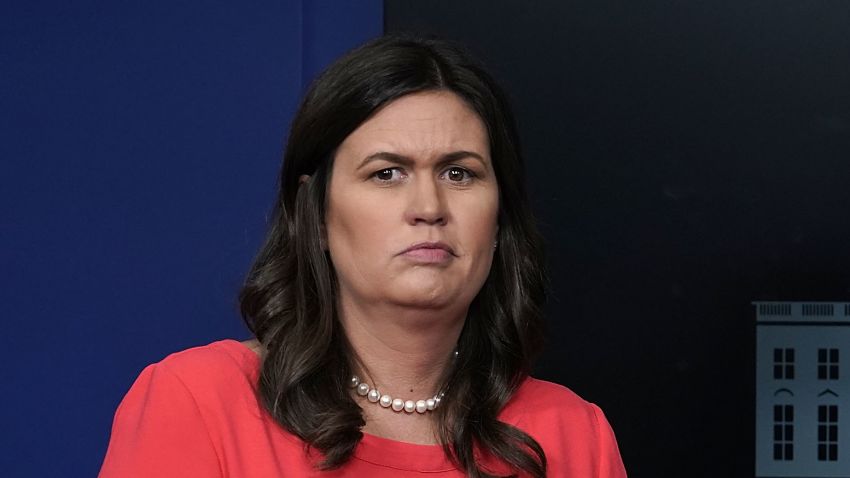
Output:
[{"xmin": 338, "ymin": 91, "xmax": 490, "ymax": 160}]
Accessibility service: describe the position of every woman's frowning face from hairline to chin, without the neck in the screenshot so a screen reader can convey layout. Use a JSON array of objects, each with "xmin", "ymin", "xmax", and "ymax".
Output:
[{"xmin": 325, "ymin": 91, "xmax": 499, "ymax": 308}]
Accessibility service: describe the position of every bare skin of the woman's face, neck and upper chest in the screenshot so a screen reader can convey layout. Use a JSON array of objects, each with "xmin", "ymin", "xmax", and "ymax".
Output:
[{"xmin": 322, "ymin": 91, "xmax": 499, "ymax": 443}]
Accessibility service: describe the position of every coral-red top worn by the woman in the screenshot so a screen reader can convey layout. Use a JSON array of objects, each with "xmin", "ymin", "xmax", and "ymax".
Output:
[{"xmin": 99, "ymin": 340, "xmax": 626, "ymax": 478}]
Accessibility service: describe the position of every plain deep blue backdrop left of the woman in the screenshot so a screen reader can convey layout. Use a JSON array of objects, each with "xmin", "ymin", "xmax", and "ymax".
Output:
[{"xmin": 0, "ymin": 0, "xmax": 383, "ymax": 477}]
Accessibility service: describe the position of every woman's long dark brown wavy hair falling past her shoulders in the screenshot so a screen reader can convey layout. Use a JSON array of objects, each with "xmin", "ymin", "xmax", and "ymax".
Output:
[{"xmin": 239, "ymin": 36, "xmax": 546, "ymax": 477}]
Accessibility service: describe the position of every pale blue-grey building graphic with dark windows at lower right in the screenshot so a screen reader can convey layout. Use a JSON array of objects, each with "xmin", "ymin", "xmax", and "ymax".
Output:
[{"xmin": 753, "ymin": 302, "xmax": 850, "ymax": 478}]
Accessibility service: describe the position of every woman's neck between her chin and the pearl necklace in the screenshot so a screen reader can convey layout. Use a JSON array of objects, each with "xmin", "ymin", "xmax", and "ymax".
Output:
[{"xmin": 340, "ymin": 297, "xmax": 466, "ymax": 401}]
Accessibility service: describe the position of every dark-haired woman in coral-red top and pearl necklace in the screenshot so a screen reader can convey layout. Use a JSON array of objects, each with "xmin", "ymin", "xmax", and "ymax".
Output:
[{"xmin": 101, "ymin": 37, "xmax": 625, "ymax": 478}]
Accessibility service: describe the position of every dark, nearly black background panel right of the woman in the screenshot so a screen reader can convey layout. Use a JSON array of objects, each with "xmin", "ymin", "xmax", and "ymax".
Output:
[{"xmin": 385, "ymin": 0, "xmax": 850, "ymax": 477}]
